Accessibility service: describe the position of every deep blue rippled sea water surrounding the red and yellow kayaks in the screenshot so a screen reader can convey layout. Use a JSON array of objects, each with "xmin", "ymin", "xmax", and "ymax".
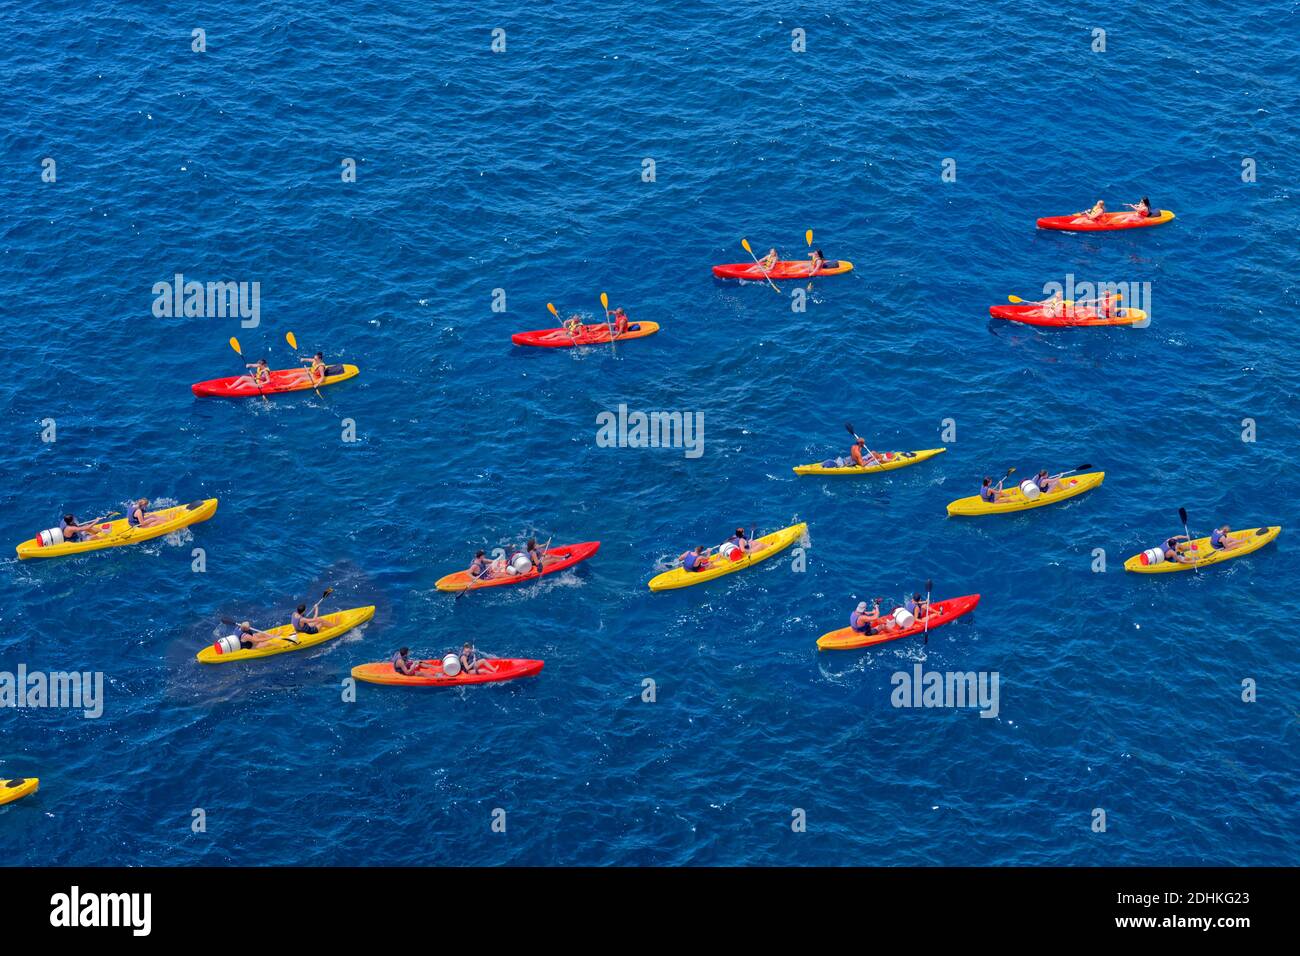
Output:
[{"xmin": 0, "ymin": 0, "xmax": 1300, "ymax": 865}]
